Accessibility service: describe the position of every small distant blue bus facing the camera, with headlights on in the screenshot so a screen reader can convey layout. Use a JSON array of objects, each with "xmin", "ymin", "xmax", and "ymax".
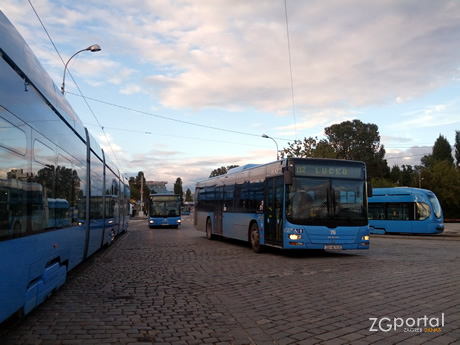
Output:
[{"xmin": 148, "ymin": 193, "xmax": 182, "ymax": 229}]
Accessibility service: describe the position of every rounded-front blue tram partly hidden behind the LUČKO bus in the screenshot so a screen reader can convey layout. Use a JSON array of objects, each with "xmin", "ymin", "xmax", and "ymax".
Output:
[{"xmin": 369, "ymin": 187, "xmax": 444, "ymax": 234}]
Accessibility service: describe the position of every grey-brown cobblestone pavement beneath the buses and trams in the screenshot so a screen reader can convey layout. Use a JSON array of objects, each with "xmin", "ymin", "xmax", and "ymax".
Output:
[{"xmin": 0, "ymin": 218, "xmax": 460, "ymax": 345}]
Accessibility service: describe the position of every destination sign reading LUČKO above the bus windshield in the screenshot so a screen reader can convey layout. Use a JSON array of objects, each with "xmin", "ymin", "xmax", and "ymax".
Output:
[{"xmin": 295, "ymin": 163, "xmax": 363, "ymax": 178}]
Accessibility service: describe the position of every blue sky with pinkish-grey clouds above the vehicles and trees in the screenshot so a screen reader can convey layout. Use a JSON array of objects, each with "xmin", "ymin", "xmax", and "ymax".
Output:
[{"xmin": 0, "ymin": 0, "xmax": 460, "ymax": 191}]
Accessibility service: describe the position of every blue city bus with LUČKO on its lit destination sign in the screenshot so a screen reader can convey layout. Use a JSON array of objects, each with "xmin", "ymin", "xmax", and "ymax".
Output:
[{"xmin": 194, "ymin": 158, "xmax": 371, "ymax": 253}]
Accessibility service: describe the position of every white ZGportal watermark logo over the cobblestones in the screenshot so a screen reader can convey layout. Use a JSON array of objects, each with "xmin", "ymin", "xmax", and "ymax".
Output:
[{"xmin": 369, "ymin": 313, "xmax": 444, "ymax": 333}]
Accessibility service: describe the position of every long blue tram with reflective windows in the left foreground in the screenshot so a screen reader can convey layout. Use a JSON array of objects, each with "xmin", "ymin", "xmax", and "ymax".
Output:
[{"xmin": 0, "ymin": 11, "xmax": 129, "ymax": 323}]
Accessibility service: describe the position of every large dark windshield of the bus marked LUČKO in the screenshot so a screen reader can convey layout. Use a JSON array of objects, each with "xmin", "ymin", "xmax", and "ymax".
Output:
[{"xmin": 286, "ymin": 177, "xmax": 368, "ymax": 227}]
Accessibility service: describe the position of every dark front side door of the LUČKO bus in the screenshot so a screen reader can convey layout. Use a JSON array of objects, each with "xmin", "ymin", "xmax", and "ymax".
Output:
[{"xmin": 264, "ymin": 176, "xmax": 284, "ymax": 246}]
